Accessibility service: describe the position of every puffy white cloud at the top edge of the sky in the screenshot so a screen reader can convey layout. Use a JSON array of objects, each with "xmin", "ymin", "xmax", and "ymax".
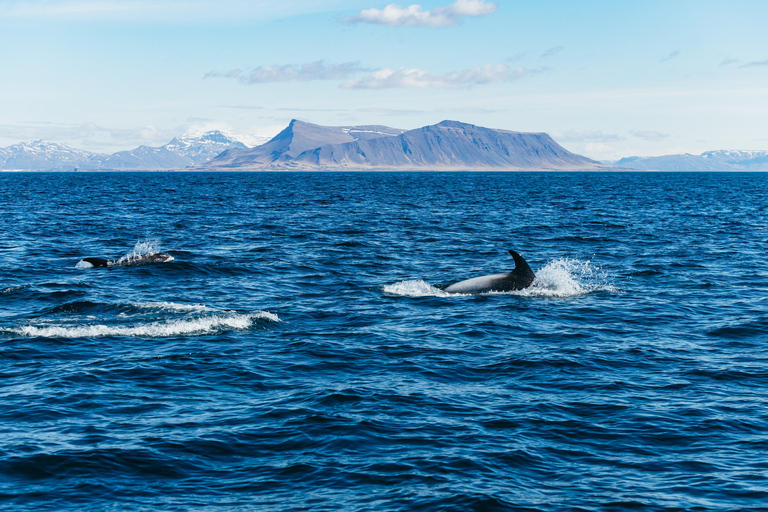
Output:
[{"xmin": 342, "ymin": 0, "xmax": 498, "ymax": 27}]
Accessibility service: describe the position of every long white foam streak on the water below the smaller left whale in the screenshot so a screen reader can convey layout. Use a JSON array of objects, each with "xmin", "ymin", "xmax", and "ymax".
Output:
[{"xmin": 12, "ymin": 311, "xmax": 280, "ymax": 338}]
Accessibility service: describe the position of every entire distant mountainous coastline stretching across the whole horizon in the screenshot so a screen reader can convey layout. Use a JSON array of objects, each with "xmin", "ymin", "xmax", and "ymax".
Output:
[{"xmin": 0, "ymin": 119, "xmax": 768, "ymax": 172}]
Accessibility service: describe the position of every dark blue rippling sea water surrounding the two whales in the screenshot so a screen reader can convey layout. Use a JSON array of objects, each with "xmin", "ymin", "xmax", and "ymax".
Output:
[{"xmin": 0, "ymin": 173, "xmax": 768, "ymax": 511}]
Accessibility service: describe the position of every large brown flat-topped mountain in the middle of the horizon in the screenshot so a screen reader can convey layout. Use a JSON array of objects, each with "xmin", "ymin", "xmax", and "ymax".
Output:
[{"xmin": 205, "ymin": 120, "xmax": 605, "ymax": 170}]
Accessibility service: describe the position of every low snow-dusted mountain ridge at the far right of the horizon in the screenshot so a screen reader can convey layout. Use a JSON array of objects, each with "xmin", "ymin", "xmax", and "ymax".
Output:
[{"xmin": 616, "ymin": 150, "xmax": 768, "ymax": 171}]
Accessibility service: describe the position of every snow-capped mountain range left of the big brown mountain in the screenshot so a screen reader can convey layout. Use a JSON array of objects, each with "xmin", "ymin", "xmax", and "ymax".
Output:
[{"xmin": 0, "ymin": 131, "xmax": 248, "ymax": 171}]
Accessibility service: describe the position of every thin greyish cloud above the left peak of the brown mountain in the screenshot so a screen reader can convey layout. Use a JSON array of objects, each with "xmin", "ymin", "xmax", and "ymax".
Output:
[{"xmin": 204, "ymin": 60, "xmax": 370, "ymax": 84}]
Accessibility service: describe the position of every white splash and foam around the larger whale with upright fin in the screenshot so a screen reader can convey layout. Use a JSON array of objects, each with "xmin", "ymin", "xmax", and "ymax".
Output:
[{"xmin": 382, "ymin": 258, "xmax": 619, "ymax": 298}]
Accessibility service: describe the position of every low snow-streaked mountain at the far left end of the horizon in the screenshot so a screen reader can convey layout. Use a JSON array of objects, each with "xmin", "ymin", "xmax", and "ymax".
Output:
[{"xmin": 0, "ymin": 140, "xmax": 106, "ymax": 170}]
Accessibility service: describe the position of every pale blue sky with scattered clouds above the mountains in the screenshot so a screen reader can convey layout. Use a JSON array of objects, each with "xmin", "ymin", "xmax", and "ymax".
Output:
[{"xmin": 0, "ymin": 0, "xmax": 768, "ymax": 160}]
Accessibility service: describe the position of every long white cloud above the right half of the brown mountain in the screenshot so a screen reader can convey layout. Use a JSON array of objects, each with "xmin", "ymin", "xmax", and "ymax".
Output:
[{"xmin": 341, "ymin": 64, "xmax": 548, "ymax": 89}]
